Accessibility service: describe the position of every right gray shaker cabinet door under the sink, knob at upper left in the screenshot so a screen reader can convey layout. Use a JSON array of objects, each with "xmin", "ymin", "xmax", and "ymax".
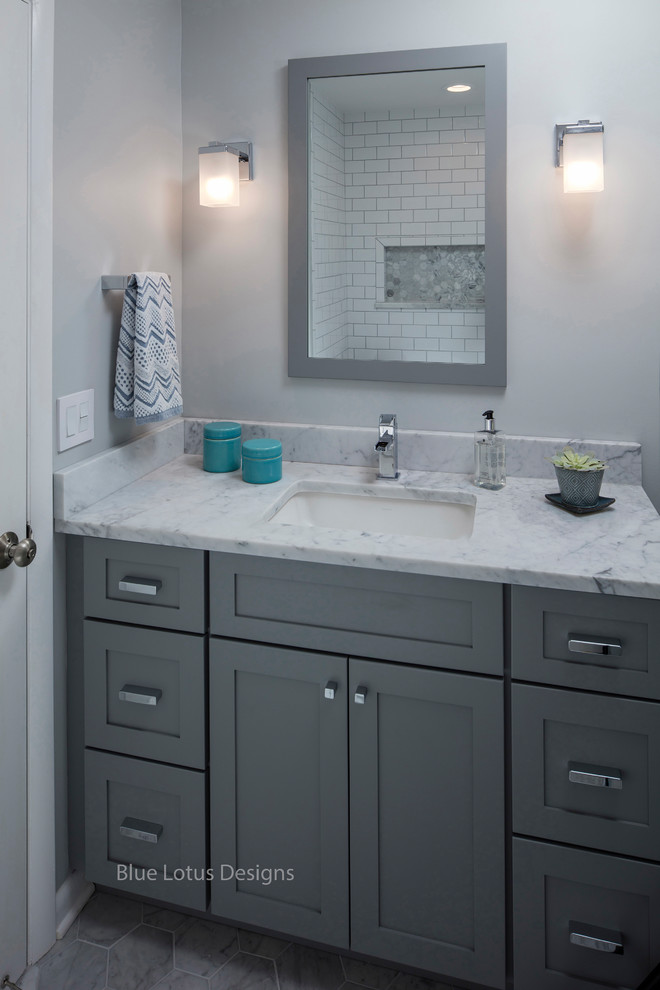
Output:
[{"xmin": 349, "ymin": 660, "xmax": 505, "ymax": 987}]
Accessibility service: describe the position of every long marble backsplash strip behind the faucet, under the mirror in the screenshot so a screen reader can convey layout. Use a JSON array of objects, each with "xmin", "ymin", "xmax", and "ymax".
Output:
[{"xmin": 184, "ymin": 419, "xmax": 642, "ymax": 491}]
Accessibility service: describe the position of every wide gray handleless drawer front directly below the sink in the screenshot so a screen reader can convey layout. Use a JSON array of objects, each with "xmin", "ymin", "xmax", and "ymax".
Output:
[{"xmin": 210, "ymin": 553, "xmax": 503, "ymax": 674}]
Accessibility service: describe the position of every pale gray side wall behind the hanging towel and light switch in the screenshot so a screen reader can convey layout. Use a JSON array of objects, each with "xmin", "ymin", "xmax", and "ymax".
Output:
[{"xmin": 53, "ymin": 0, "xmax": 182, "ymax": 470}]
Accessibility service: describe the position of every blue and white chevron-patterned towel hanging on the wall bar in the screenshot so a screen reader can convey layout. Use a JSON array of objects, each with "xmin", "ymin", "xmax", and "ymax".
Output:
[{"xmin": 114, "ymin": 272, "xmax": 182, "ymax": 423}]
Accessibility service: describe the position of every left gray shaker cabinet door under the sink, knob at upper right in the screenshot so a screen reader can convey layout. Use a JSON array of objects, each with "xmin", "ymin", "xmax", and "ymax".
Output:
[{"xmin": 209, "ymin": 639, "xmax": 348, "ymax": 948}]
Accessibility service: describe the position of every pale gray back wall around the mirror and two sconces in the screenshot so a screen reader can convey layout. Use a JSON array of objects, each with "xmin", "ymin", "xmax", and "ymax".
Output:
[{"xmin": 182, "ymin": 0, "xmax": 660, "ymax": 504}]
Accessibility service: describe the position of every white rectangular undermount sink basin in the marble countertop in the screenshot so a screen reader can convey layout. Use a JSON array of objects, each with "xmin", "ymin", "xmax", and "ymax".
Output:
[{"xmin": 267, "ymin": 486, "xmax": 476, "ymax": 540}]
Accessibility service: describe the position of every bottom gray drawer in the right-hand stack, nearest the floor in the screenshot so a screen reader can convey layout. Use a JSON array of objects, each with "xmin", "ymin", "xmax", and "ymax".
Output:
[{"xmin": 513, "ymin": 839, "xmax": 660, "ymax": 990}]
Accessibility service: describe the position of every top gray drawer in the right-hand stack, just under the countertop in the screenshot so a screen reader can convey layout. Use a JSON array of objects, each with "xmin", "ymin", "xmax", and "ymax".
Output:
[{"xmin": 511, "ymin": 587, "xmax": 660, "ymax": 698}]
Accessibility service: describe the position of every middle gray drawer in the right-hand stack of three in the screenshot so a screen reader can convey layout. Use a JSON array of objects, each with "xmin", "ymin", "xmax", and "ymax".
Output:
[{"xmin": 512, "ymin": 684, "xmax": 660, "ymax": 860}]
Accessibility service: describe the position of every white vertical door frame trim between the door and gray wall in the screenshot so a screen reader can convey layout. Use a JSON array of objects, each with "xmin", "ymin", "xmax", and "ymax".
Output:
[{"xmin": 24, "ymin": 0, "xmax": 55, "ymax": 965}]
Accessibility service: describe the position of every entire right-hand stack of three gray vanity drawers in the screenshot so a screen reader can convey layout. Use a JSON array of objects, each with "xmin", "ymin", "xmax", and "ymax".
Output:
[{"xmin": 511, "ymin": 587, "xmax": 660, "ymax": 990}]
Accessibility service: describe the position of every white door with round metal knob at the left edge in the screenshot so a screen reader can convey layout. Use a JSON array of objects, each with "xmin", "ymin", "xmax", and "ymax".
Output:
[{"xmin": 0, "ymin": 0, "xmax": 30, "ymax": 980}]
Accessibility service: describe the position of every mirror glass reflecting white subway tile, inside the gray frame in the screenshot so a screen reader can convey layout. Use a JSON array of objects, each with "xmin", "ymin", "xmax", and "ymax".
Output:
[{"xmin": 308, "ymin": 66, "xmax": 486, "ymax": 364}]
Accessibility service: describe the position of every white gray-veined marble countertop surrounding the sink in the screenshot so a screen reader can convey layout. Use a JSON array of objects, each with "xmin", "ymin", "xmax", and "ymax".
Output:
[{"xmin": 56, "ymin": 441, "xmax": 660, "ymax": 598}]
